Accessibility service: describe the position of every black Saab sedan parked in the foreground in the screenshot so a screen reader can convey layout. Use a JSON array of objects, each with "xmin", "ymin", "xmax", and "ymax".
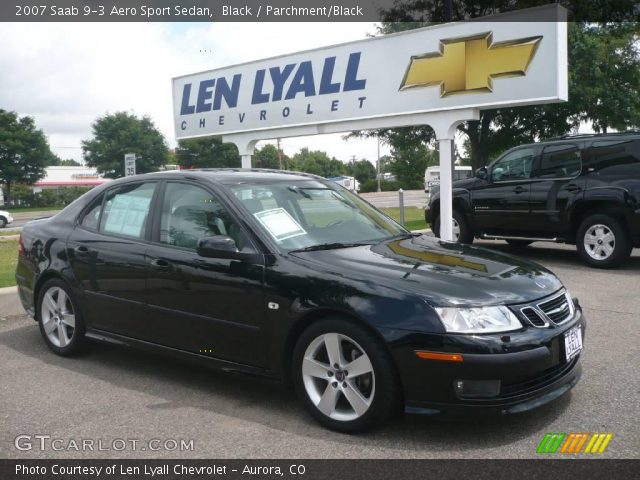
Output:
[{"xmin": 16, "ymin": 170, "xmax": 586, "ymax": 432}]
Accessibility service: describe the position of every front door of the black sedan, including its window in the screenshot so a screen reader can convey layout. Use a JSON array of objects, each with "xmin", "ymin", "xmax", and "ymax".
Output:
[{"xmin": 147, "ymin": 182, "xmax": 266, "ymax": 366}]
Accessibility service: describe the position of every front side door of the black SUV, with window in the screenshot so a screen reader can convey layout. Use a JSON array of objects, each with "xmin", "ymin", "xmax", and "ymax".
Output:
[{"xmin": 471, "ymin": 146, "xmax": 539, "ymax": 235}]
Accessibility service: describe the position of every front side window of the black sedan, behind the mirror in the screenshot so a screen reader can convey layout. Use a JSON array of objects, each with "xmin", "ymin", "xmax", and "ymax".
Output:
[{"xmin": 160, "ymin": 182, "xmax": 246, "ymax": 250}]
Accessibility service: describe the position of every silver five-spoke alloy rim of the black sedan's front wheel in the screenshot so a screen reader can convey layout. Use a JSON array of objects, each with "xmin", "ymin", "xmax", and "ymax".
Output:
[{"xmin": 302, "ymin": 333, "xmax": 375, "ymax": 422}]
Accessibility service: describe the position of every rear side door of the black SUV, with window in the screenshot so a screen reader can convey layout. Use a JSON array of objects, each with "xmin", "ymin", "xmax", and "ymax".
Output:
[{"xmin": 530, "ymin": 142, "xmax": 585, "ymax": 237}]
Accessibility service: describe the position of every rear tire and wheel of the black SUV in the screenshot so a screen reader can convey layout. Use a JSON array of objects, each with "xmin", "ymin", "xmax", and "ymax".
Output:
[{"xmin": 576, "ymin": 214, "xmax": 633, "ymax": 268}]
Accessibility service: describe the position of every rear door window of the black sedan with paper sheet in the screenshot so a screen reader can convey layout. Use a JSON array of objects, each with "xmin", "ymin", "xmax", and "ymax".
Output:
[{"xmin": 100, "ymin": 182, "xmax": 156, "ymax": 238}]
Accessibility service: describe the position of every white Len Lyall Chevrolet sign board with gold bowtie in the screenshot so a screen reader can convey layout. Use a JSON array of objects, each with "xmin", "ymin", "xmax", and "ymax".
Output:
[{"xmin": 173, "ymin": 15, "xmax": 567, "ymax": 138}]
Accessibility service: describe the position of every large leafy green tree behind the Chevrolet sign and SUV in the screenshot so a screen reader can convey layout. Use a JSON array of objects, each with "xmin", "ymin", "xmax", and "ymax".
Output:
[{"xmin": 352, "ymin": 0, "xmax": 640, "ymax": 168}]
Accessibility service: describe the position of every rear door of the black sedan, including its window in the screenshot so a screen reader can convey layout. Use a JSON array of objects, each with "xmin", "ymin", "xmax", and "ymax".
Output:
[{"xmin": 67, "ymin": 182, "xmax": 158, "ymax": 339}]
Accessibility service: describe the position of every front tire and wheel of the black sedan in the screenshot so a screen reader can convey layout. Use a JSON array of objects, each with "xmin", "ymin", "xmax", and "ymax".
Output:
[{"xmin": 292, "ymin": 318, "xmax": 400, "ymax": 433}]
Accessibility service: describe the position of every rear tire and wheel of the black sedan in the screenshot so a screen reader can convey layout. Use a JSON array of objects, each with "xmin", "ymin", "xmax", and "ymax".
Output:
[{"xmin": 36, "ymin": 279, "xmax": 86, "ymax": 356}]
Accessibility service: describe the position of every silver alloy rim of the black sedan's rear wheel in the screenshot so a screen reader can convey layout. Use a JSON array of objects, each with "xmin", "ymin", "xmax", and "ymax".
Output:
[{"xmin": 40, "ymin": 287, "xmax": 76, "ymax": 348}]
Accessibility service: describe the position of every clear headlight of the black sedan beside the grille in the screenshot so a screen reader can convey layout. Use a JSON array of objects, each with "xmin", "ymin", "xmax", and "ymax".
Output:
[{"xmin": 435, "ymin": 307, "xmax": 522, "ymax": 333}]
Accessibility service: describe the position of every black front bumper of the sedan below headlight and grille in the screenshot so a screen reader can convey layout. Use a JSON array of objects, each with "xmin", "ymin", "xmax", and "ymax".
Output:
[{"xmin": 387, "ymin": 308, "xmax": 586, "ymax": 416}]
